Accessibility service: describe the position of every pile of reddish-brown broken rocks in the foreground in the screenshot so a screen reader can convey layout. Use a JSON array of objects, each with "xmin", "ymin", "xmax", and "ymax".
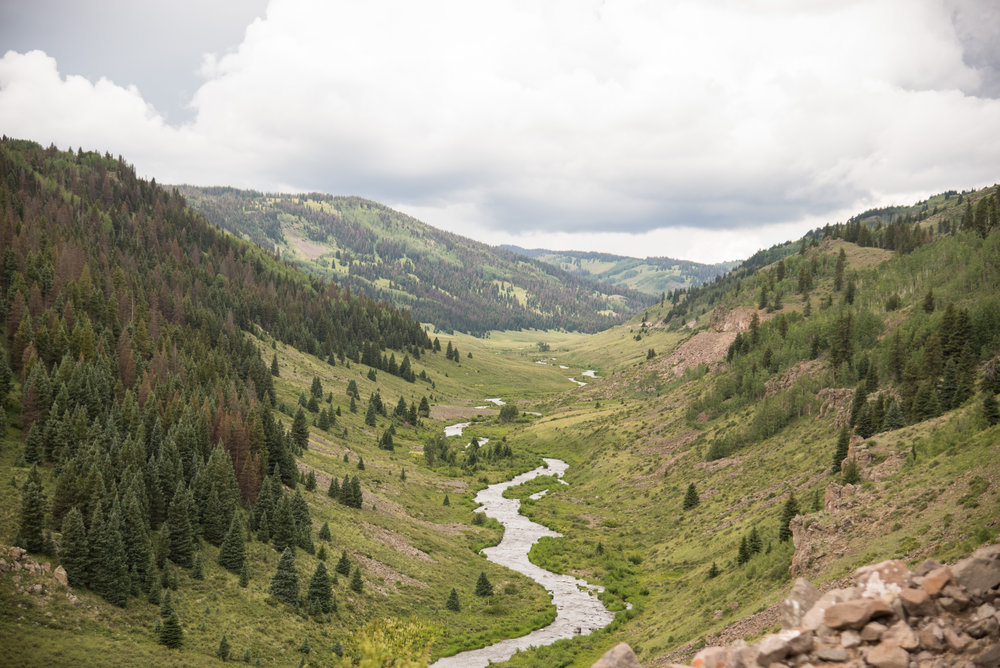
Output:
[{"xmin": 594, "ymin": 545, "xmax": 1000, "ymax": 668}]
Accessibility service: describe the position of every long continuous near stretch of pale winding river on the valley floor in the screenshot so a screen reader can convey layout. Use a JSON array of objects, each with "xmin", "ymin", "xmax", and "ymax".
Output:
[{"xmin": 432, "ymin": 458, "xmax": 614, "ymax": 668}]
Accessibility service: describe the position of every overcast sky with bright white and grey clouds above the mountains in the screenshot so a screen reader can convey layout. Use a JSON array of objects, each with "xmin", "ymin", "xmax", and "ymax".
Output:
[{"xmin": 0, "ymin": 0, "xmax": 1000, "ymax": 262}]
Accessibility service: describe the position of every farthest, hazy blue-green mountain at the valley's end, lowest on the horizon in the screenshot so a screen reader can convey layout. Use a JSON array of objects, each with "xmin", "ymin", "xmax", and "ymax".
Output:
[{"xmin": 501, "ymin": 245, "xmax": 739, "ymax": 296}]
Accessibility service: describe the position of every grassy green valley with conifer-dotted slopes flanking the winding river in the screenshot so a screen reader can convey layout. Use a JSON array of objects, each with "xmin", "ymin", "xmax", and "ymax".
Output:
[{"xmin": 0, "ymin": 140, "xmax": 1000, "ymax": 666}]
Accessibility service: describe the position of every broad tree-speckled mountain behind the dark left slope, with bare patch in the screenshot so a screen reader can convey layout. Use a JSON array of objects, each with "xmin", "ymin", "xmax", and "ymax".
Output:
[{"xmin": 172, "ymin": 186, "xmax": 654, "ymax": 334}]
